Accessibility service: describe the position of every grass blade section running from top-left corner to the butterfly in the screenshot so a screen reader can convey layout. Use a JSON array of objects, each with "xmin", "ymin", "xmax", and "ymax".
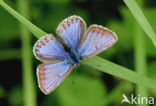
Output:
[{"xmin": 0, "ymin": 0, "xmax": 46, "ymax": 38}]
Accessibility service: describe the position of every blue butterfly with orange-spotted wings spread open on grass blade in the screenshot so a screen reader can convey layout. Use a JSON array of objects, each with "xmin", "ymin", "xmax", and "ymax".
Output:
[{"xmin": 33, "ymin": 15, "xmax": 118, "ymax": 94}]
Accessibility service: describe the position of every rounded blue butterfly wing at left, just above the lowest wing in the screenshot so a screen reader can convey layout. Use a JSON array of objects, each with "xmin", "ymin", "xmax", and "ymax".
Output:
[{"xmin": 33, "ymin": 35, "xmax": 67, "ymax": 63}]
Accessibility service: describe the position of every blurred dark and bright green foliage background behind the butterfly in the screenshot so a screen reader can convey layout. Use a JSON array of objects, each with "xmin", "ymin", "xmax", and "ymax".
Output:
[{"xmin": 0, "ymin": 0, "xmax": 156, "ymax": 106}]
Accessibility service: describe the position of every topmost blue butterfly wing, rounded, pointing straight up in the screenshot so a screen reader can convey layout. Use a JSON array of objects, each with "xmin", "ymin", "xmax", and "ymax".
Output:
[{"xmin": 56, "ymin": 16, "xmax": 86, "ymax": 50}]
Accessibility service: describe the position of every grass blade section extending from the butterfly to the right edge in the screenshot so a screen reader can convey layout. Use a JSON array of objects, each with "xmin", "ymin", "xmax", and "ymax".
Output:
[{"xmin": 82, "ymin": 56, "xmax": 156, "ymax": 89}]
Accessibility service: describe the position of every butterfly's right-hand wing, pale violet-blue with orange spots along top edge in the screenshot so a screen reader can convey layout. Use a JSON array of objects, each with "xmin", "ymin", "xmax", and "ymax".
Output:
[{"xmin": 79, "ymin": 25, "xmax": 118, "ymax": 59}]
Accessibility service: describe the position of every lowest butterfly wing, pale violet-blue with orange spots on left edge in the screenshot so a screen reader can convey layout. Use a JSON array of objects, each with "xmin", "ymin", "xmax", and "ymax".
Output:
[{"xmin": 37, "ymin": 60, "xmax": 74, "ymax": 94}]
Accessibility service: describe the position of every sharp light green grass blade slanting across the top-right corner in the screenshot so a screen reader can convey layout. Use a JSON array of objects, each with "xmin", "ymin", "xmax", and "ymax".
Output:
[{"xmin": 123, "ymin": 0, "xmax": 156, "ymax": 46}]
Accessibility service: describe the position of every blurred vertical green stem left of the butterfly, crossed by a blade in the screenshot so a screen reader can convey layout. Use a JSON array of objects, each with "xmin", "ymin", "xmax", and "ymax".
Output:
[{"xmin": 17, "ymin": 0, "xmax": 37, "ymax": 106}]
